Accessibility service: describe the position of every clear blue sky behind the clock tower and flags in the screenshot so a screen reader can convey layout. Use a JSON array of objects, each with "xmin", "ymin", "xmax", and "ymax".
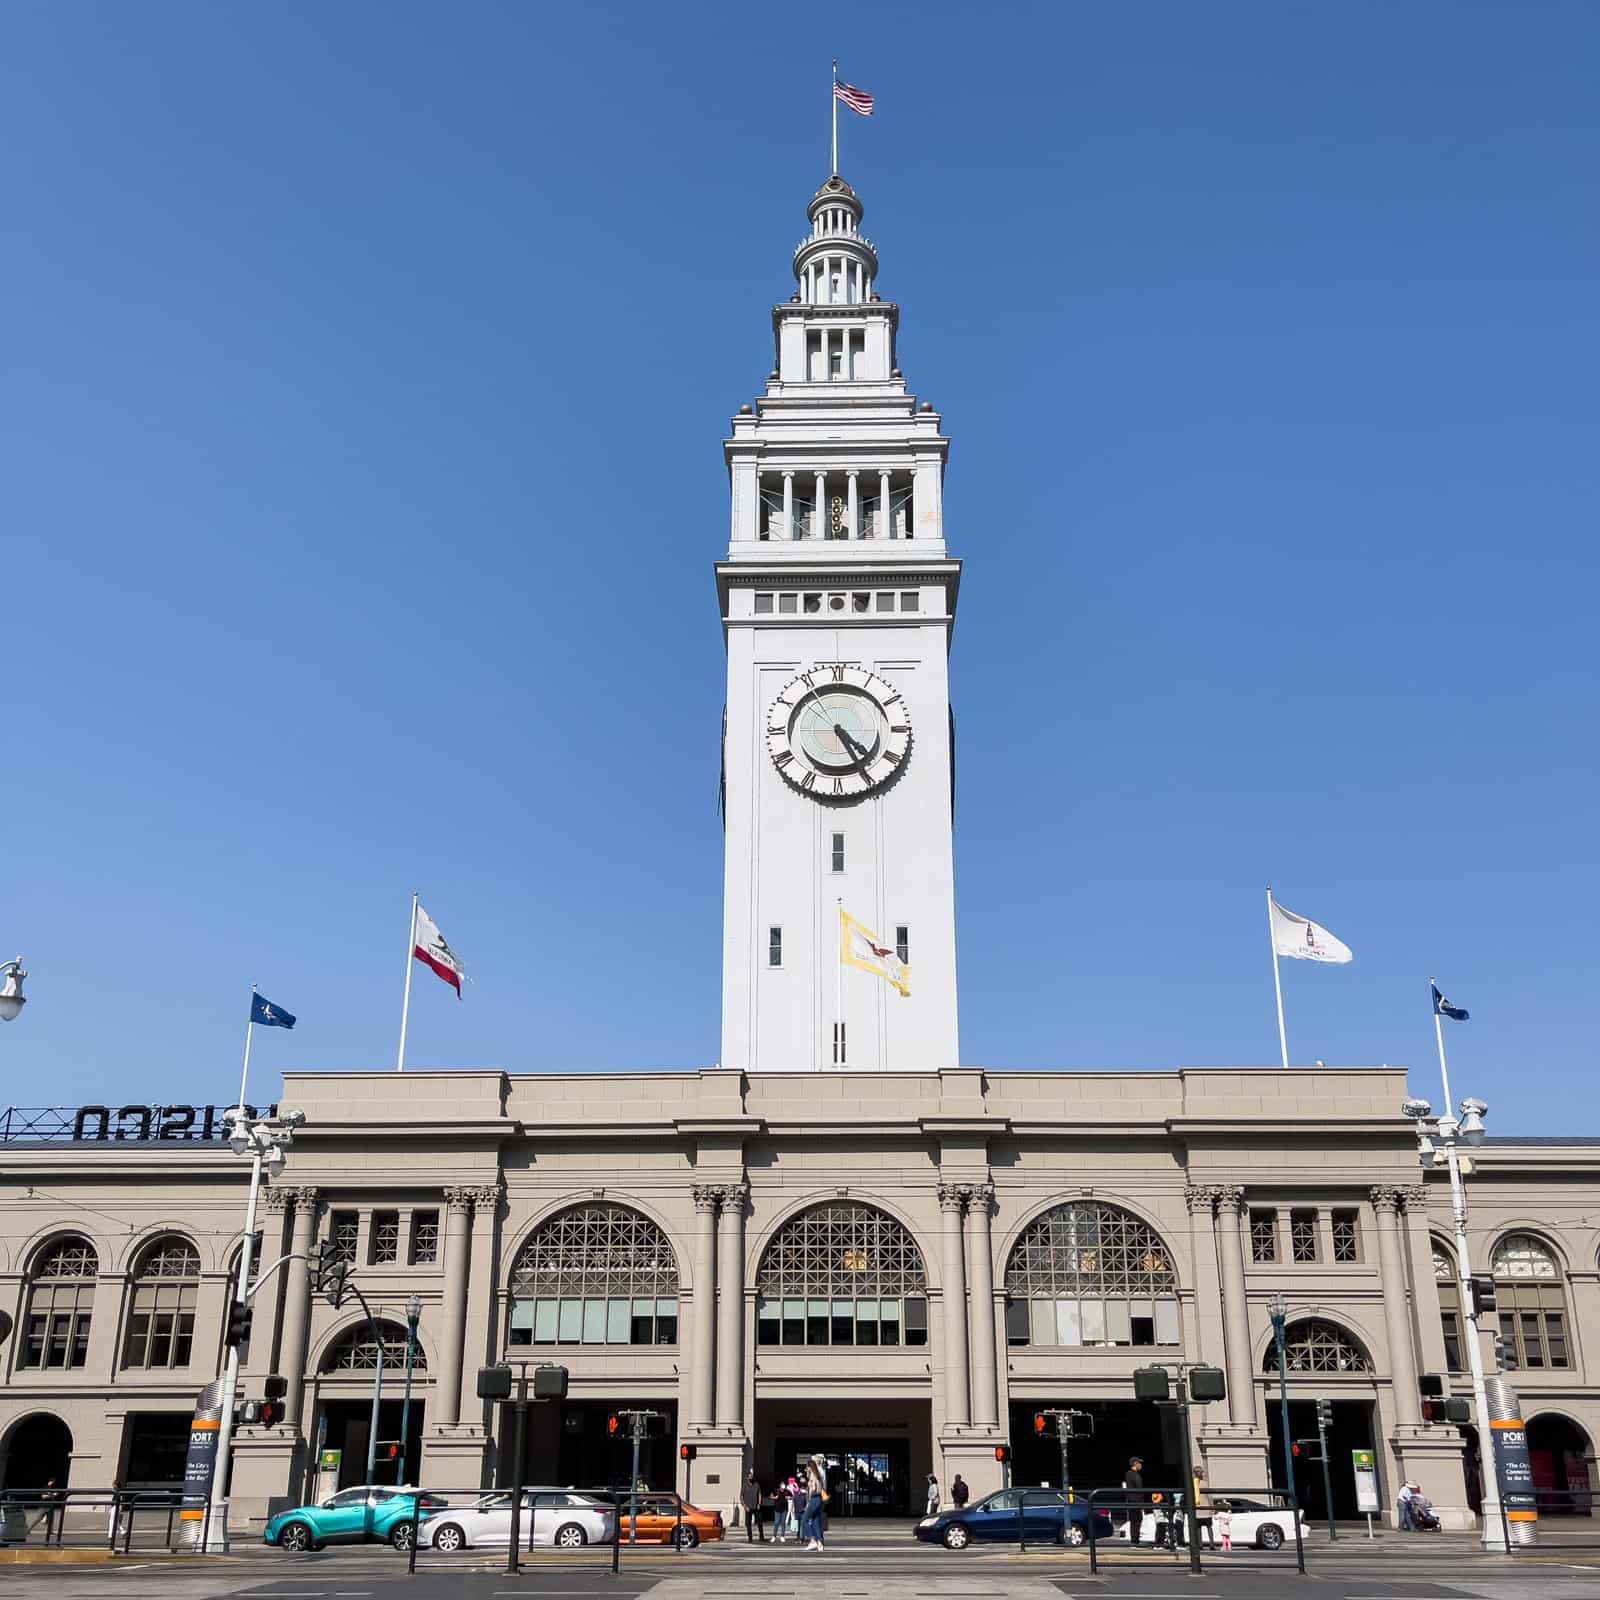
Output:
[{"xmin": 0, "ymin": 0, "xmax": 1600, "ymax": 1133}]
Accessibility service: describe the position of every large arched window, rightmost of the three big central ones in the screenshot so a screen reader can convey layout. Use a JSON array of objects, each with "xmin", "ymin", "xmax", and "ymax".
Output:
[{"xmin": 1005, "ymin": 1200, "xmax": 1182, "ymax": 1346}]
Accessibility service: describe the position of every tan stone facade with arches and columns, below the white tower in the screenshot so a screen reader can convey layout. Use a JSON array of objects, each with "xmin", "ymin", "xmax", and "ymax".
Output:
[{"xmin": 0, "ymin": 1067, "xmax": 1600, "ymax": 1525}]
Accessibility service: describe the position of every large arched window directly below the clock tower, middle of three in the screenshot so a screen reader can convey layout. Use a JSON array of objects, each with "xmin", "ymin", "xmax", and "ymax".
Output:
[{"xmin": 755, "ymin": 1200, "xmax": 928, "ymax": 1346}]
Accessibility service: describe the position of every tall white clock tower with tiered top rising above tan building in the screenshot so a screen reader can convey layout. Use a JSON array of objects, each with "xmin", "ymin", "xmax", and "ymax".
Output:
[{"xmin": 717, "ymin": 176, "xmax": 962, "ymax": 1072}]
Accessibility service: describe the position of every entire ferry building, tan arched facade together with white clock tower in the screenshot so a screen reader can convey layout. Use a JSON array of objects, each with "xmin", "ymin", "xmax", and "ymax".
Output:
[{"xmin": 0, "ymin": 176, "xmax": 1600, "ymax": 1528}]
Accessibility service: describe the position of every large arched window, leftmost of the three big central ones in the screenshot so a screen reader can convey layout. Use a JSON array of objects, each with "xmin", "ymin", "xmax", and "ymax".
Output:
[{"xmin": 506, "ymin": 1205, "xmax": 678, "ymax": 1344}]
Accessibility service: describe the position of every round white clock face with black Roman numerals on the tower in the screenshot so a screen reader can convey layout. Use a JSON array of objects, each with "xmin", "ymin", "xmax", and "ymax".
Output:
[{"xmin": 766, "ymin": 661, "xmax": 910, "ymax": 800}]
